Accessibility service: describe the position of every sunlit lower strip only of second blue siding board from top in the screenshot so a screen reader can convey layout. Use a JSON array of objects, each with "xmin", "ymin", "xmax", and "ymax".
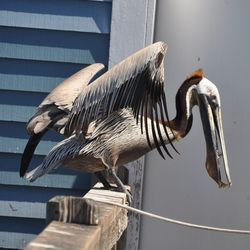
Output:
[{"xmin": 0, "ymin": 42, "xmax": 103, "ymax": 64}]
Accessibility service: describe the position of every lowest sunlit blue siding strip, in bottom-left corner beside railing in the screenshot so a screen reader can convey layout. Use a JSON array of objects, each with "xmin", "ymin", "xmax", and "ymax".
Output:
[{"xmin": 0, "ymin": 231, "xmax": 36, "ymax": 249}]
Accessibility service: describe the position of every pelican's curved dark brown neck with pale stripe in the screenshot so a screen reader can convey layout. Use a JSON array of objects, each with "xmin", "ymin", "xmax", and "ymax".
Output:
[{"xmin": 170, "ymin": 75, "xmax": 202, "ymax": 138}]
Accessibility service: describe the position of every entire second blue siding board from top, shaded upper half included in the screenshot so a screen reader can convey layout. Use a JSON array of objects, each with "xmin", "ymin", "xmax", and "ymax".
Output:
[{"xmin": 0, "ymin": 27, "xmax": 109, "ymax": 64}]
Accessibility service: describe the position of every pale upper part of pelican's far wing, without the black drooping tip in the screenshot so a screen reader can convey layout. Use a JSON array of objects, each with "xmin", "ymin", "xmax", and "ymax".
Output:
[{"xmin": 27, "ymin": 63, "xmax": 104, "ymax": 134}]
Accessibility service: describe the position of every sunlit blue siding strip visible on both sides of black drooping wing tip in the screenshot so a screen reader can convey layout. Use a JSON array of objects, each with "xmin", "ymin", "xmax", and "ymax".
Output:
[{"xmin": 0, "ymin": 136, "xmax": 56, "ymax": 155}]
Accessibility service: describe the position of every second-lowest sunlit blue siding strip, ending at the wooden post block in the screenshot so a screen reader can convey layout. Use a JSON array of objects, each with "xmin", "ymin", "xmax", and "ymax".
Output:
[{"xmin": 0, "ymin": 201, "xmax": 46, "ymax": 219}]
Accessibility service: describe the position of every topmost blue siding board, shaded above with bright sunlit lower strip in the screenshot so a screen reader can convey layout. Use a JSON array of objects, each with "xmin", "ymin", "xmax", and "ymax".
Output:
[{"xmin": 0, "ymin": 0, "xmax": 111, "ymax": 34}]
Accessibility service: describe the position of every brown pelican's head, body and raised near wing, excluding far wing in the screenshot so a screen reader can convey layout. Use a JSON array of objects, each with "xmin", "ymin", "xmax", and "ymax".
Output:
[{"xmin": 26, "ymin": 42, "xmax": 231, "ymax": 202}]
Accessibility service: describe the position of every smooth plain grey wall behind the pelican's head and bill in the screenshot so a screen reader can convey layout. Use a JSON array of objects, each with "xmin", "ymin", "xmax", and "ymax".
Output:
[{"xmin": 140, "ymin": 0, "xmax": 250, "ymax": 250}]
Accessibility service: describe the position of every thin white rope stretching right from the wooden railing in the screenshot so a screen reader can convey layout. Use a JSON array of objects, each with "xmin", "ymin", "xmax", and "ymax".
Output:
[{"xmin": 90, "ymin": 198, "xmax": 250, "ymax": 234}]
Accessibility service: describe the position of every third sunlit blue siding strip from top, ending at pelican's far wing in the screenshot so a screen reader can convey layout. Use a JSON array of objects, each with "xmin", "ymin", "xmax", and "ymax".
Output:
[{"xmin": 0, "ymin": 73, "xmax": 65, "ymax": 93}]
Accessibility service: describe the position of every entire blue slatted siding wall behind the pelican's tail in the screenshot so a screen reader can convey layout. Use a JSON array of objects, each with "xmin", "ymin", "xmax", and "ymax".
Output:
[{"xmin": 0, "ymin": 0, "xmax": 112, "ymax": 249}]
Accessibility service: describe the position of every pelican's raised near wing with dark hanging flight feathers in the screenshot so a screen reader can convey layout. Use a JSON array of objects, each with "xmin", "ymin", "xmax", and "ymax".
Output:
[{"xmin": 65, "ymin": 42, "xmax": 175, "ymax": 158}]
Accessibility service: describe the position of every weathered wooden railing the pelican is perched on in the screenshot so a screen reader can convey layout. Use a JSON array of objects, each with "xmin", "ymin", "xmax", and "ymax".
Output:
[{"xmin": 25, "ymin": 184, "xmax": 128, "ymax": 250}]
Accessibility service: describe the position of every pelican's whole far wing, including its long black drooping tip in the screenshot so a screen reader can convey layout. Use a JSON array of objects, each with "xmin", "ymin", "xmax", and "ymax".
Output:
[{"xmin": 20, "ymin": 63, "xmax": 104, "ymax": 177}]
